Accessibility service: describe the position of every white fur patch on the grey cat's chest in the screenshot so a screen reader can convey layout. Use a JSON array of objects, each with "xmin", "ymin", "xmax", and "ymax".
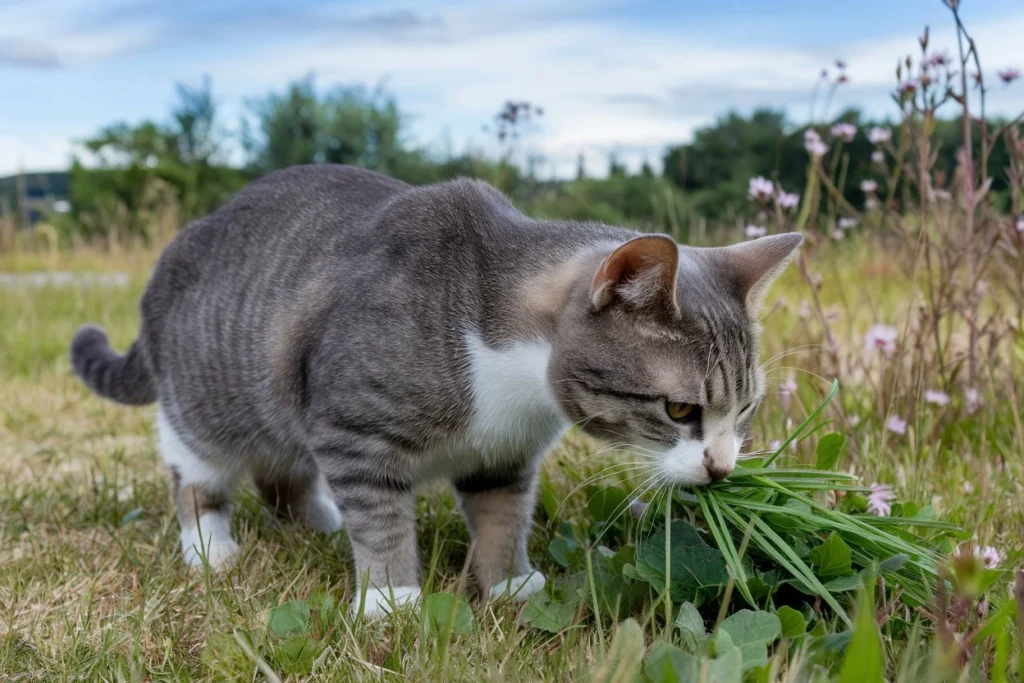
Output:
[{"xmin": 419, "ymin": 334, "xmax": 568, "ymax": 476}]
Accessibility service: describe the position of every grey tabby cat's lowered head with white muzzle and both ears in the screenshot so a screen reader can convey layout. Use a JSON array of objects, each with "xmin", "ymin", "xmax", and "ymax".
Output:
[{"xmin": 548, "ymin": 233, "xmax": 803, "ymax": 485}]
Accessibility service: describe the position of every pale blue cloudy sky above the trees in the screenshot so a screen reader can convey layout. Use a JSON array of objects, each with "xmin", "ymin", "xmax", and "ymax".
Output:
[{"xmin": 0, "ymin": 0, "xmax": 1024, "ymax": 176}]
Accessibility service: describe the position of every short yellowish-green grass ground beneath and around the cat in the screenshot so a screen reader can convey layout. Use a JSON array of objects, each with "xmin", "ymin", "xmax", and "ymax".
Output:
[{"xmin": 0, "ymin": 236, "xmax": 1024, "ymax": 681}]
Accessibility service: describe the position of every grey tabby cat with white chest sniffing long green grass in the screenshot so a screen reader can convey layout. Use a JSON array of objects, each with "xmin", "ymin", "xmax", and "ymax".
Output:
[{"xmin": 71, "ymin": 165, "xmax": 802, "ymax": 616}]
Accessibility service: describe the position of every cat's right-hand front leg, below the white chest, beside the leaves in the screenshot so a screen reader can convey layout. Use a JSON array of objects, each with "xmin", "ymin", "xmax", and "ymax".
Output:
[{"xmin": 454, "ymin": 463, "xmax": 545, "ymax": 601}]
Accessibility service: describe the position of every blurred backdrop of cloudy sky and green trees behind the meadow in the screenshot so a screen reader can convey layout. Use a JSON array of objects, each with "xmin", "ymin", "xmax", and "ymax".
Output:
[{"xmin": 0, "ymin": 0, "xmax": 1024, "ymax": 241}]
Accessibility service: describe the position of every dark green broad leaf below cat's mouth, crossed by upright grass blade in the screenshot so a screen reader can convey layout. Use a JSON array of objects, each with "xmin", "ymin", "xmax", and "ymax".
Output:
[{"xmin": 635, "ymin": 521, "xmax": 729, "ymax": 605}]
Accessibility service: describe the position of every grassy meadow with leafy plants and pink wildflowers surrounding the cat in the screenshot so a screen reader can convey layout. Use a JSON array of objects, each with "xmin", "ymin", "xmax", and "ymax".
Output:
[{"xmin": 0, "ymin": 2, "xmax": 1024, "ymax": 683}]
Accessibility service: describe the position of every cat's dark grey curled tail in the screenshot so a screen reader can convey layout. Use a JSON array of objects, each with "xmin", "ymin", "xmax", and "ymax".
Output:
[{"xmin": 71, "ymin": 325, "xmax": 157, "ymax": 405}]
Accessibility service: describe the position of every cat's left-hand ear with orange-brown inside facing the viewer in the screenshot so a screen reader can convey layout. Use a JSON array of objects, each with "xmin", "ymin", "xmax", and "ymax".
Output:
[{"xmin": 590, "ymin": 234, "xmax": 679, "ymax": 312}]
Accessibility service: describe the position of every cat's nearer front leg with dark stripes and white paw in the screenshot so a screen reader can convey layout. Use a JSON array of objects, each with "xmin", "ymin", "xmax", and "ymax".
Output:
[{"xmin": 317, "ymin": 457, "xmax": 421, "ymax": 618}]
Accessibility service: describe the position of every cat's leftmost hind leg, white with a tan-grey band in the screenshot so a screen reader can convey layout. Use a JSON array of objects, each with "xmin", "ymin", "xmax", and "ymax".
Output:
[{"xmin": 157, "ymin": 409, "xmax": 240, "ymax": 569}]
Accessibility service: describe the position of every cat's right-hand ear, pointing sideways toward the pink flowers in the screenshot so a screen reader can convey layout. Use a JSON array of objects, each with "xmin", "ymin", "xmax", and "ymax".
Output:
[{"xmin": 720, "ymin": 232, "xmax": 804, "ymax": 315}]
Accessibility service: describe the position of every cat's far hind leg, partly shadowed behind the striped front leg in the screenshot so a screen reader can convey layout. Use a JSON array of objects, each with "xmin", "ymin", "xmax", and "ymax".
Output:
[{"xmin": 253, "ymin": 456, "xmax": 342, "ymax": 536}]
